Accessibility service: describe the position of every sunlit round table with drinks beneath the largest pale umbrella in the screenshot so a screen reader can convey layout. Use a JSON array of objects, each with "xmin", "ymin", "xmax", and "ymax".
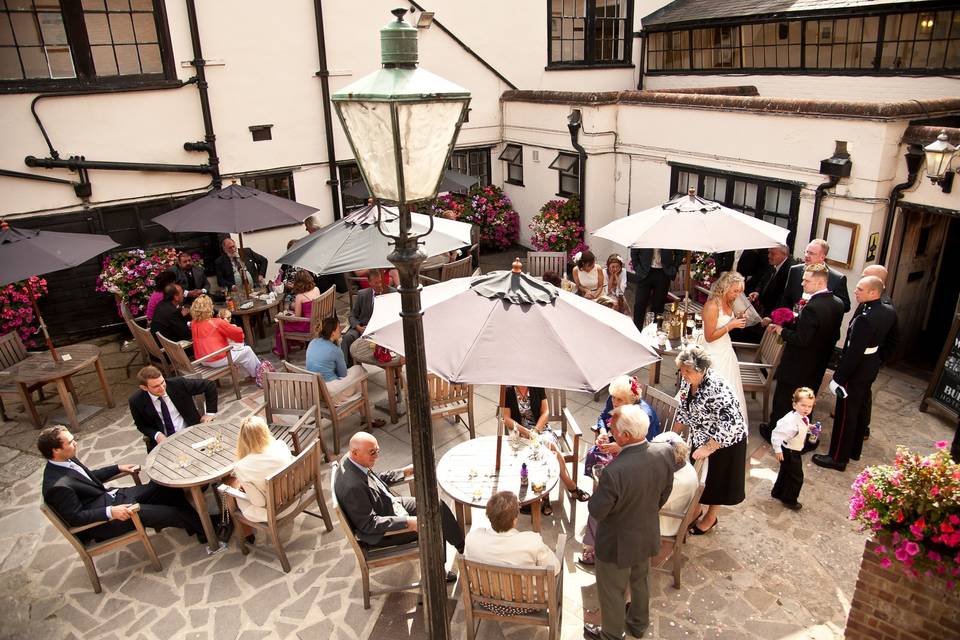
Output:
[{"xmin": 437, "ymin": 436, "xmax": 560, "ymax": 531}]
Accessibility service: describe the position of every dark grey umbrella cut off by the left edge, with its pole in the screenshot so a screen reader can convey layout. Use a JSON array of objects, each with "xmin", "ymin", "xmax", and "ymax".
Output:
[{"xmin": 0, "ymin": 222, "xmax": 118, "ymax": 360}]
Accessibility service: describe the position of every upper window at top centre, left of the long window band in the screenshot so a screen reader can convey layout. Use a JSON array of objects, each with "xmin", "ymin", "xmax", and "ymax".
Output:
[{"xmin": 547, "ymin": 0, "xmax": 633, "ymax": 65}]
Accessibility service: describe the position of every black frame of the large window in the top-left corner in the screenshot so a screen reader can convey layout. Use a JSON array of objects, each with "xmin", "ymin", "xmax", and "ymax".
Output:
[{"xmin": 0, "ymin": 0, "xmax": 179, "ymax": 93}]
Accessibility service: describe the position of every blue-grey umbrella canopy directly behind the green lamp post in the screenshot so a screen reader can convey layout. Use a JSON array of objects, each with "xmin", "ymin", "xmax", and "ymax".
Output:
[{"xmin": 277, "ymin": 205, "xmax": 471, "ymax": 274}]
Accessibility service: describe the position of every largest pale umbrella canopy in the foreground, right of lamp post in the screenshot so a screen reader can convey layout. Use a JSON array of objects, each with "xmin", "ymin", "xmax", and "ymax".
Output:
[{"xmin": 364, "ymin": 271, "xmax": 660, "ymax": 392}]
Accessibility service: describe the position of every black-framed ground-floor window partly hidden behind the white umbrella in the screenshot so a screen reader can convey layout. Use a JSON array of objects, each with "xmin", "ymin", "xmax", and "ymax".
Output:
[{"xmin": 671, "ymin": 166, "xmax": 800, "ymax": 246}]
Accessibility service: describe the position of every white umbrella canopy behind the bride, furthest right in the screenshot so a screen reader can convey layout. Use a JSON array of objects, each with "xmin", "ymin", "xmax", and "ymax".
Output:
[{"xmin": 592, "ymin": 189, "xmax": 789, "ymax": 252}]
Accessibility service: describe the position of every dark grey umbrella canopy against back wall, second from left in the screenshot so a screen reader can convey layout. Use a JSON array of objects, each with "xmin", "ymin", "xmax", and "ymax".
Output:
[{"xmin": 154, "ymin": 184, "xmax": 317, "ymax": 233}]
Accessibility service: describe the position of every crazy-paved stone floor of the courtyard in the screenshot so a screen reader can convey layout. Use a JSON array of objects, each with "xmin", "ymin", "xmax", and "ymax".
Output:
[{"xmin": 0, "ymin": 258, "xmax": 952, "ymax": 640}]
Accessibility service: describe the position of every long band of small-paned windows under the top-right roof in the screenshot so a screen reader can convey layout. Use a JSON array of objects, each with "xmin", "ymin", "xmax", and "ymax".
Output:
[{"xmin": 646, "ymin": 9, "xmax": 960, "ymax": 73}]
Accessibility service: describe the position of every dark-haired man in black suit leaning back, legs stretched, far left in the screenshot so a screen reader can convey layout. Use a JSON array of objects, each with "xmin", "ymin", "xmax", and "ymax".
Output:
[{"xmin": 37, "ymin": 425, "xmax": 206, "ymax": 543}]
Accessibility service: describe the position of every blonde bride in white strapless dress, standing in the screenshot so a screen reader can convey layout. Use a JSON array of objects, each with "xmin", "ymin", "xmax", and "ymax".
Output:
[{"xmin": 701, "ymin": 271, "xmax": 747, "ymax": 421}]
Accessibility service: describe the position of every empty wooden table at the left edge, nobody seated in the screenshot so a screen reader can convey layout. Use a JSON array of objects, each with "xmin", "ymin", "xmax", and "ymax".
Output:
[{"xmin": 0, "ymin": 344, "xmax": 114, "ymax": 429}]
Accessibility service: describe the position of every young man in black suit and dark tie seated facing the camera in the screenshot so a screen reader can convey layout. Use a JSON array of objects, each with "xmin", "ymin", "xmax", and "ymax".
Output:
[{"xmin": 128, "ymin": 366, "xmax": 218, "ymax": 453}]
